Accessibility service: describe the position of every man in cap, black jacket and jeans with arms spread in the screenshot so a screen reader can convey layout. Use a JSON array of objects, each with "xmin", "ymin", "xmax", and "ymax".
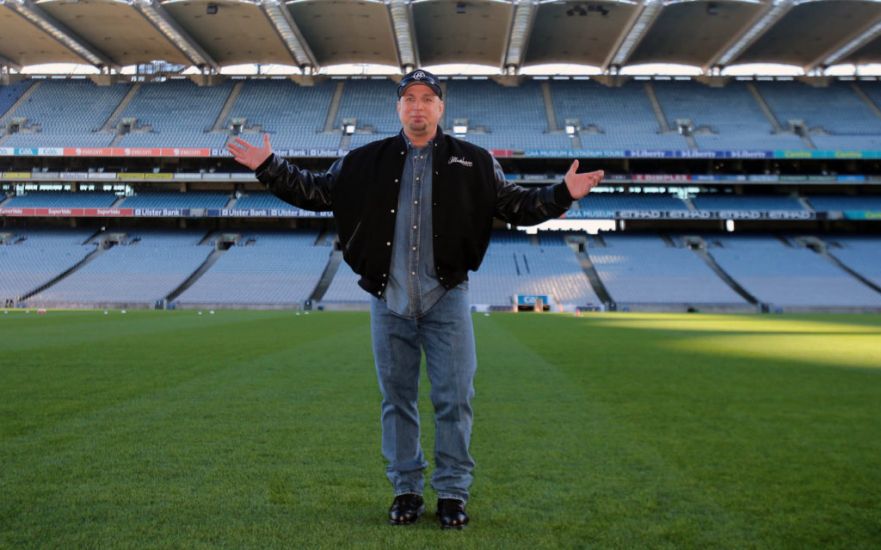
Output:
[{"xmin": 227, "ymin": 70, "xmax": 603, "ymax": 528}]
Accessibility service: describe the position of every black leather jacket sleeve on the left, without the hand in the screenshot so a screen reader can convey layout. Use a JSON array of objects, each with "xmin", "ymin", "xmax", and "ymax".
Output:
[{"xmin": 255, "ymin": 154, "xmax": 343, "ymax": 212}]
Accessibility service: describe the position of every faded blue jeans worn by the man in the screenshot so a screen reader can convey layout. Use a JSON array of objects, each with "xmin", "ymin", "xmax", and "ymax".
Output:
[{"xmin": 370, "ymin": 287, "xmax": 477, "ymax": 502}]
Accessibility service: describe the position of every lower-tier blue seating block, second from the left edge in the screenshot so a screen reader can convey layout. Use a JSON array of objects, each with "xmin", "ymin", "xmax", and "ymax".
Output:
[{"xmin": 27, "ymin": 229, "xmax": 212, "ymax": 307}]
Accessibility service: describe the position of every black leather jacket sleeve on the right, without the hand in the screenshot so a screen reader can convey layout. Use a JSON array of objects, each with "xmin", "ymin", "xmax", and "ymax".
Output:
[{"xmin": 493, "ymin": 159, "xmax": 573, "ymax": 225}]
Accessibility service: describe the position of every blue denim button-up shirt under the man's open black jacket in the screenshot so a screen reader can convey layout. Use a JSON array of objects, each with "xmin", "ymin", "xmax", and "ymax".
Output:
[{"xmin": 385, "ymin": 140, "xmax": 446, "ymax": 318}]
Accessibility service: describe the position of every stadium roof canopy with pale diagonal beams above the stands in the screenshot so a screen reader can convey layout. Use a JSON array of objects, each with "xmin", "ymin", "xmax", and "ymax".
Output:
[{"xmin": 0, "ymin": 0, "xmax": 881, "ymax": 74}]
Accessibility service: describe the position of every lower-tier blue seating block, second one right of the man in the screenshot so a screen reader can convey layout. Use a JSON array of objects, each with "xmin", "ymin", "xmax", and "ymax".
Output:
[{"xmin": 587, "ymin": 234, "xmax": 747, "ymax": 309}]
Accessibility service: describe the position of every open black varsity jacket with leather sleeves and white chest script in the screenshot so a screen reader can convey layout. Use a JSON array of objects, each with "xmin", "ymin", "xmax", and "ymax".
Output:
[{"xmin": 256, "ymin": 128, "xmax": 572, "ymax": 296}]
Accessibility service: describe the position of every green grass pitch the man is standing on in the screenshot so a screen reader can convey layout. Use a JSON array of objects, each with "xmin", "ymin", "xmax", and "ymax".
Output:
[{"xmin": 0, "ymin": 311, "xmax": 881, "ymax": 549}]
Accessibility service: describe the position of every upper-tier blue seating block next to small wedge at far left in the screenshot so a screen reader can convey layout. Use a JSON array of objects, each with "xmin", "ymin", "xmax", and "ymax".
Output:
[{"xmin": 2, "ymin": 80, "xmax": 130, "ymax": 147}]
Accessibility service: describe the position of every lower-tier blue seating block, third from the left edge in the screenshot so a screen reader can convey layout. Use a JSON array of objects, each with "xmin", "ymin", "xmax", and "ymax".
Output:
[{"xmin": 177, "ymin": 231, "xmax": 331, "ymax": 308}]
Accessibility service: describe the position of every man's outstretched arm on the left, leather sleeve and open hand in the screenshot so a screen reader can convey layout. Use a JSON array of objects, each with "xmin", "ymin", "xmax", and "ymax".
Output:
[{"xmin": 226, "ymin": 134, "xmax": 342, "ymax": 211}]
